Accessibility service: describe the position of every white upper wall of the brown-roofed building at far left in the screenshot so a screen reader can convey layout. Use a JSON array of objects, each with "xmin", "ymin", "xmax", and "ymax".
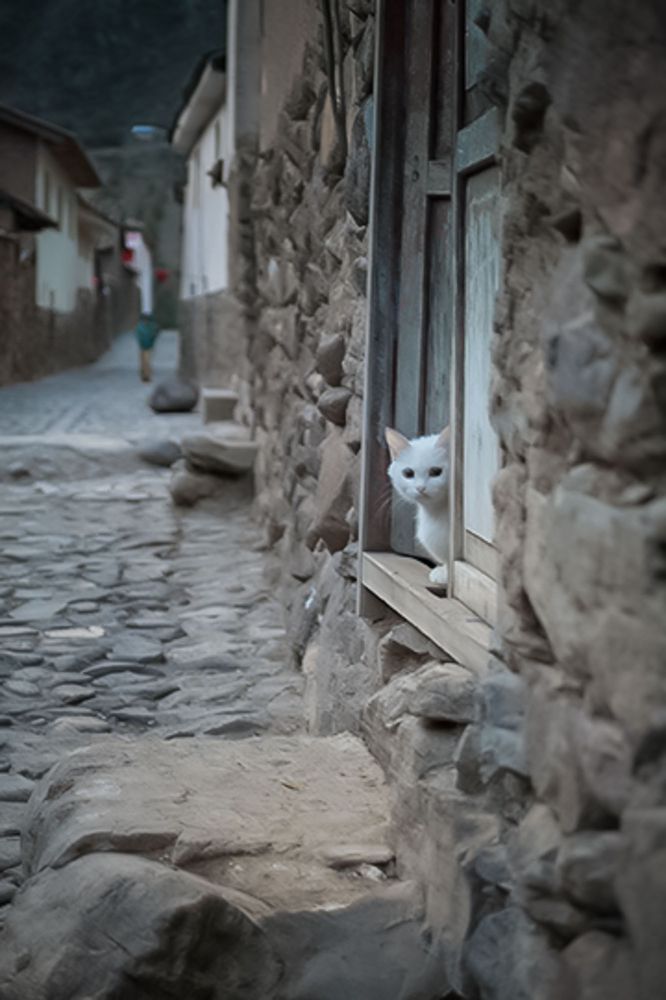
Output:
[{"xmin": 35, "ymin": 143, "xmax": 80, "ymax": 312}]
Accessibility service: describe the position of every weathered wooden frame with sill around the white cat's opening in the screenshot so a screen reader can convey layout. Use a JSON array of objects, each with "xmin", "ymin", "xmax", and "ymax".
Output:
[{"xmin": 358, "ymin": 0, "xmax": 500, "ymax": 671}]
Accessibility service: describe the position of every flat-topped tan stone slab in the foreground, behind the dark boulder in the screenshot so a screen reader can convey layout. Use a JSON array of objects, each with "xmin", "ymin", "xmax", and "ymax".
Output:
[{"xmin": 23, "ymin": 735, "xmax": 388, "ymax": 909}]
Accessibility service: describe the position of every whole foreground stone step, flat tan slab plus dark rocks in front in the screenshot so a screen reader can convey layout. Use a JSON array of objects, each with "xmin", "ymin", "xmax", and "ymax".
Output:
[{"xmin": 0, "ymin": 735, "xmax": 447, "ymax": 1000}]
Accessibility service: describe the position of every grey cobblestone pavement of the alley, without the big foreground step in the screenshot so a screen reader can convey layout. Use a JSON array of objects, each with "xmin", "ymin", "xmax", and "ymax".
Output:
[{"xmin": 0, "ymin": 338, "xmax": 301, "ymax": 919}]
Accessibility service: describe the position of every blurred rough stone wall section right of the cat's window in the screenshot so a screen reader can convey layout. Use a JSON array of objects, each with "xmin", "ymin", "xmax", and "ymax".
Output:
[{"xmin": 471, "ymin": 0, "xmax": 666, "ymax": 1000}]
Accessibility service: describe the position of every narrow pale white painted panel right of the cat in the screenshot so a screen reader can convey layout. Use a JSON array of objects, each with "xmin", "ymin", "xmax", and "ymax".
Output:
[{"xmin": 463, "ymin": 167, "xmax": 499, "ymax": 541}]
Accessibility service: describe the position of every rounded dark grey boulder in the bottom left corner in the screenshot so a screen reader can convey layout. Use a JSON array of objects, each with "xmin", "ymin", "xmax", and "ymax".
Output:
[{"xmin": 0, "ymin": 854, "xmax": 280, "ymax": 1000}]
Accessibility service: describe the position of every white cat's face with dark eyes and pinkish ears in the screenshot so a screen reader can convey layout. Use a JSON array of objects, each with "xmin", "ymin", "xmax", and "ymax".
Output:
[{"xmin": 386, "ymin": 427, "xmax": 449, "ymax": 506}]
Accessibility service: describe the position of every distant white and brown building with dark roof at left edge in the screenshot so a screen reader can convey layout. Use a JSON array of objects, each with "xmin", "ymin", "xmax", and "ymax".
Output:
[{"xmin": 0, "ymin": 105, "xmax": 136, "ymax": 382}]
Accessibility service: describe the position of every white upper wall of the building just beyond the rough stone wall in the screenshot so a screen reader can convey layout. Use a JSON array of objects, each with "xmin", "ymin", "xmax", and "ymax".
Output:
[{"xmin": 181, "ymin": 108, "xmax": 230, "ymax": 299}]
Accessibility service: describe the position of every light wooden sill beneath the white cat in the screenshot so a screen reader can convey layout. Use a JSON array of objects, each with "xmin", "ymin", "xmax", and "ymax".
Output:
[{"xmin": 361, "ymin": 552, "xmax": 491, "ymax": 673}]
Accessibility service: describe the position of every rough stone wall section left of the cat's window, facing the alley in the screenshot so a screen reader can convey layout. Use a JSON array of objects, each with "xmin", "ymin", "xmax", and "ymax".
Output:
[{"xmin": 230, "ymin": 0, "xmax": 375, "ymax": 733}]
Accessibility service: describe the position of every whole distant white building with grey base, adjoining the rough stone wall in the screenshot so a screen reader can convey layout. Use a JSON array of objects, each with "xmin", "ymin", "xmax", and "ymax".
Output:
[{"xmin": 170, "ymin": 51, "xmax": 244, "ymax": 384}]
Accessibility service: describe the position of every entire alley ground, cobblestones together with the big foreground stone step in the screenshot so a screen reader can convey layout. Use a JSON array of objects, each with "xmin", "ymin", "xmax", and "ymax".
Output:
[{"xmin": 0, "ymin": 335, "xmax": 442, "ymax": 1000}]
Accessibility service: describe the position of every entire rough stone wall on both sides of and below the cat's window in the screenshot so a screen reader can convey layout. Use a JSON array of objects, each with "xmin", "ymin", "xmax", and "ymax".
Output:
[{"xmin": 232, "ymin": 0, "xmax": 666, "ymax": 1000}]
